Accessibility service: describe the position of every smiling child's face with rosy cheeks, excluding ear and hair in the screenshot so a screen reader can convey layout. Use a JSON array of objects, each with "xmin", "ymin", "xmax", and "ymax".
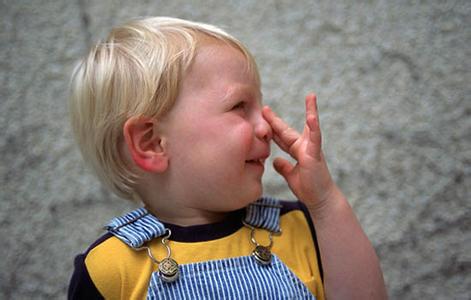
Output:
[{"xmin": 162, "ymin": 43, "xmax": 272, "ymax": 220}]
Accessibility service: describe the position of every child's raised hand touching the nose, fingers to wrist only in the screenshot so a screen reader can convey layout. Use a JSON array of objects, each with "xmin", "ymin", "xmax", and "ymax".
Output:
[{"xmin": 263, "ymin": 94, "xmax": 337, "ymax": 212}]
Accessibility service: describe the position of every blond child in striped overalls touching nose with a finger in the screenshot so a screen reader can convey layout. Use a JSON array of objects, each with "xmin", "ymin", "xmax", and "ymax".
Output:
[{"xmin": 69, "ymin": 18, "xmax": 386, "ymax": 299}]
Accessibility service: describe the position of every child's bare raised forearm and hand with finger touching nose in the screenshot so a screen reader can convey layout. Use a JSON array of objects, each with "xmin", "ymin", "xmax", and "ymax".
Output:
[{"xmin": 263, "ymin": 94, "xmax": 387, "ymax": 299}]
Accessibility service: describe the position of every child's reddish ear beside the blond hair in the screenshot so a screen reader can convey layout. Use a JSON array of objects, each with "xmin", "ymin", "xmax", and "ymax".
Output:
[{"xmin": 123, "ymin": 117, "xmax": 168, "ymax": 173}]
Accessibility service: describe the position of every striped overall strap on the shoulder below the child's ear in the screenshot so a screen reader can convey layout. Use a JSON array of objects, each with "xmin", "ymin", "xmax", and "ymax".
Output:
[{"xmin": 105, "ymin": 207, "xmax": 166, "ymax": 248}]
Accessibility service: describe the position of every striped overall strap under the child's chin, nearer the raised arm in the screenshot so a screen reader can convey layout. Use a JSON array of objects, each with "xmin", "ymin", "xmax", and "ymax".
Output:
[{"xmin": 244, "ymin": 197, "xmax": 282, "ymax": 232}]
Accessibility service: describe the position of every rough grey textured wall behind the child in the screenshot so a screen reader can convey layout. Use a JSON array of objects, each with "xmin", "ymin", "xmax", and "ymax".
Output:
[{"xmin": 0, "ymin": 0, "xmax": 471, "ymax": 299}]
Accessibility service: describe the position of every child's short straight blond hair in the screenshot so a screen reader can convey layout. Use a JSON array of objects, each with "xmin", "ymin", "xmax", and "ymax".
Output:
[{"xmin": 70, "ymin": 17, "xmax": 260, "ymax": 199}]
